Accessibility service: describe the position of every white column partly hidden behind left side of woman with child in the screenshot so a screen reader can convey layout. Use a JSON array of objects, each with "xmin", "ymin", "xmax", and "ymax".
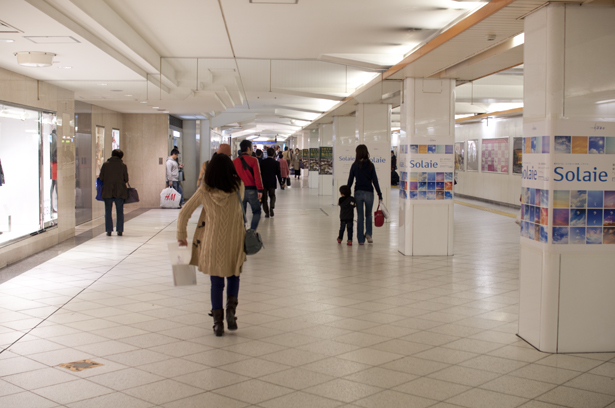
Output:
[{"xmin": 332, "ymin": 116, "xmax": 357, "ymax": 205}]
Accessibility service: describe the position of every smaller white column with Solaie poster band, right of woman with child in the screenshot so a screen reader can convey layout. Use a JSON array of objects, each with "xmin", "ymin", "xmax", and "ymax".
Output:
[{"xmin": 398, "ymin": 78, "xmax": 455, "ymax": 255}]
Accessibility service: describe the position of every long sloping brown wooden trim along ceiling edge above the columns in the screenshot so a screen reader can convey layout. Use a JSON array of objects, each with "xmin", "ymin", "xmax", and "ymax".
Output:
[{"xmin": 382, "ymin": 0, "xmax": 516, "ymax": 79}]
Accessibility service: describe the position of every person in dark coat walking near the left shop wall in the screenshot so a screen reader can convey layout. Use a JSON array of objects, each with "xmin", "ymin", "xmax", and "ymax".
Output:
[{"xmin": 98, "ymin": 149, "xmax": 128, "ymax": 236}]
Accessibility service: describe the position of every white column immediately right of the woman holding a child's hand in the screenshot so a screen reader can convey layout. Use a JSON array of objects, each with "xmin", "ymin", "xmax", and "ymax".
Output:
[{"xmin": 357, "ymin": 103, "xmax": 391, "ymax": 215}]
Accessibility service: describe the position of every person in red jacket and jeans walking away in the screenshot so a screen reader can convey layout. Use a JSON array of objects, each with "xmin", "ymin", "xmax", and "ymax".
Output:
[{"xmin": 233, "ymin": 140, "xmax": 263, "ymax": 231}]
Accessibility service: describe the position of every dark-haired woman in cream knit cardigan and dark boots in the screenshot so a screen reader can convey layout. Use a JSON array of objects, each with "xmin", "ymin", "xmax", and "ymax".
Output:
[{"xmin": 177, "ymin": 154, "xmax": 246, "ymax": 336}]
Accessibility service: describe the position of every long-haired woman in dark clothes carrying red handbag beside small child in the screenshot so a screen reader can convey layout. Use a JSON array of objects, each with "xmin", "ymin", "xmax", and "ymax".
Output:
[{"xmin": 347, "ymin": 145, "xmax": 382, "ymax": 245}]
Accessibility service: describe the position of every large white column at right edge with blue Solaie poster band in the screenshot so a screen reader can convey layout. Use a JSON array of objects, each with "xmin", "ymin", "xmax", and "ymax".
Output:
[{"xmin": 519, "ymin": 4, "xmax": 615, "ymax": 353}]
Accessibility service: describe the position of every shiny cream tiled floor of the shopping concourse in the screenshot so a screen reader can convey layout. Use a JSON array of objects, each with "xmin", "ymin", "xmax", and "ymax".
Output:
[{"xmin": 0, "ymin": 183, "xmax": 615, "ymax": 408}]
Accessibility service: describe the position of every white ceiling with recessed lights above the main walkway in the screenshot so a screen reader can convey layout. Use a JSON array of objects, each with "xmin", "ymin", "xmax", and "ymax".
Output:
[{"xmin": 0, "ymin": 0, "xmax": 531, "ymax": 138}]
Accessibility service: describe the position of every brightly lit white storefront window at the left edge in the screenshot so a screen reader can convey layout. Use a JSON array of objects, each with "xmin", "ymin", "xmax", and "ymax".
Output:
[{"xmin": 0, "ymin": 105, "xmax": 58, "ymax": 245}]
